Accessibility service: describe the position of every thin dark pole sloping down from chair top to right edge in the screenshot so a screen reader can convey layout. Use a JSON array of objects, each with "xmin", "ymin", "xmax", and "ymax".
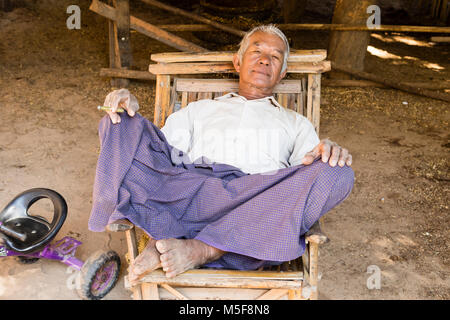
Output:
[{"xmin": 331, "ymin": 62, "xmax": 450, "ymax": 102}]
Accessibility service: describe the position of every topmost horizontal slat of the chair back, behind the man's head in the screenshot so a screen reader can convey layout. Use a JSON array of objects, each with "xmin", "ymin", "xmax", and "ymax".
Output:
[{"xmin": 150, "ymin": 49, "xmax": 327, "ymax": 63}]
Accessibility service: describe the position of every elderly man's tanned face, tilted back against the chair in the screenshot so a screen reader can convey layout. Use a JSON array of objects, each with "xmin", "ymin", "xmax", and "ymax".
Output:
[{"xmin": 233, "ymin": 31, "xmax": 286, "ymax": 94}]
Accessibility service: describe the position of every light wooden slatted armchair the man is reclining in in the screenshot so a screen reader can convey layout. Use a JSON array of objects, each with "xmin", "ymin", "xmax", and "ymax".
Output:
[{"xmin": 108, "ymin": 50, "xmax": 330, "ymax": 299}]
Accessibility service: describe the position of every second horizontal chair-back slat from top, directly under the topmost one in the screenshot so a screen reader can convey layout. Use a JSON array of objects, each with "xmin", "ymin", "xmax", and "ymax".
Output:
[{"xmin": 148, "ymin": 61, "xmax": 331, "ymax": 74}]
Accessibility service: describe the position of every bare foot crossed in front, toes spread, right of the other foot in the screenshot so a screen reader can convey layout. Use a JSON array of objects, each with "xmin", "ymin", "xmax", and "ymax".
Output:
[{"xmin": 156, "ymin": 238, "xmax": 225, "ymax": 278}]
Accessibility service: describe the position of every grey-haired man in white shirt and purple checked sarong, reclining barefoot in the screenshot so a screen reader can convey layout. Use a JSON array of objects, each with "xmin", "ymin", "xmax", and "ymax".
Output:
[{"xmin": 90, "ymin": 25, "xmax": 353, "ymax": 278}]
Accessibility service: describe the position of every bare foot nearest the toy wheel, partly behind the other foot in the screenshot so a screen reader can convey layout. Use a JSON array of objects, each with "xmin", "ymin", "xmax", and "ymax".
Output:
[{"xmin": 129, "ymin": 239, "xmax": 161, "ymax": 281}]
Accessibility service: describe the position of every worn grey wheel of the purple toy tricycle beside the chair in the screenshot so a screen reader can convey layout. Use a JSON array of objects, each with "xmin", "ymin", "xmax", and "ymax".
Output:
[{"xmin": 77, "ymin": 251, "xmax": 120, "ymax": 300}]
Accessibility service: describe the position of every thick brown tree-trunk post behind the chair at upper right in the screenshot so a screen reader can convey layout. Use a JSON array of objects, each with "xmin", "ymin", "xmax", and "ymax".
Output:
[{"xmin": 328, "ymin": 0, "xmax": 374, "ymax": 79}]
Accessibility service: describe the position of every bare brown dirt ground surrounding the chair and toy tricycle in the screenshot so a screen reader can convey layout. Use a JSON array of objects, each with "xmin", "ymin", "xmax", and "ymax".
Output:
[{"xmin": 0, "ymin": 0, "xmax": 450, "ymax": 300}]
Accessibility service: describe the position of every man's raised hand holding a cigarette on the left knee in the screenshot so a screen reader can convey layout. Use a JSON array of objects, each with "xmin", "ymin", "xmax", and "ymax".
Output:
[{"xmin": 103, "ymin": 89, "xmax": 139, "ymax": 124}]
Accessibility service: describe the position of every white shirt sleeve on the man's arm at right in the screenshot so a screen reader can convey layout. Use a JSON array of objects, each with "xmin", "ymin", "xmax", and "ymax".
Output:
[{"xmin": 289, "ymin": 115, "xmax": 320, "ymax": 166}]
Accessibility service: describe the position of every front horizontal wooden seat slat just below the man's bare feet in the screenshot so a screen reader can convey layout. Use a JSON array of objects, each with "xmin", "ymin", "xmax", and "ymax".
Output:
[{"xmin": 132, "ymin": 269, "xmax": 303, "ymax": 290}]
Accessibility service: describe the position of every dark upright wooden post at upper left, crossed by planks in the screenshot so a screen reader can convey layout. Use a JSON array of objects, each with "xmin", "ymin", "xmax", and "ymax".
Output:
[{"xmin": 108, "ymin": 0, "xmax": 132, "ymax": 88}]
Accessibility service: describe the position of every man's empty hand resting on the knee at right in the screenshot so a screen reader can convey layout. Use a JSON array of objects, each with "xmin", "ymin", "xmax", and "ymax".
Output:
[{"xmin": 302, "ymin": 139, "xmax": 352, "ymax": 167}]
